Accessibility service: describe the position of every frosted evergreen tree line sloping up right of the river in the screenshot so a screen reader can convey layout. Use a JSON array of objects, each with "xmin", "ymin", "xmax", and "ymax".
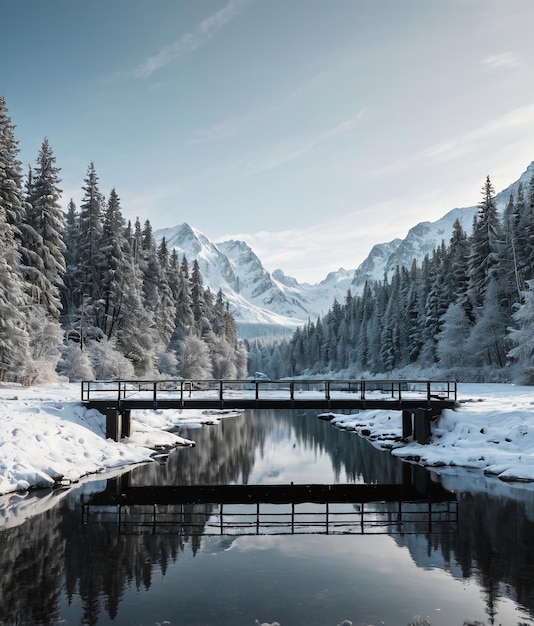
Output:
[{"xmin": 248, "ymin": 176, "xmax": 534, "ymax": 384}]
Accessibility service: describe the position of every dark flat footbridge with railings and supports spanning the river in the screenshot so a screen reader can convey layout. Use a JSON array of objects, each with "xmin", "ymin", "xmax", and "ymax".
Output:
[{"xmin": 81, "ymin": 379, "xmax": 457, "ymax": 443}]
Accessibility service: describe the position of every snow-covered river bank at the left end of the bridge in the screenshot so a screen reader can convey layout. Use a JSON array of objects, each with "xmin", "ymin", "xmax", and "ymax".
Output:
[{"xmin": 0, "ymin": 383, "xmax": 241, "ymax": 495}]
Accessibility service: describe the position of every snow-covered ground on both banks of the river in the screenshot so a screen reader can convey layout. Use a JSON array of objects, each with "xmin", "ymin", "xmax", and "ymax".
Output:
[{"xmin": 0, "ymin": 383, "xmax": 534, "ymax": 495}]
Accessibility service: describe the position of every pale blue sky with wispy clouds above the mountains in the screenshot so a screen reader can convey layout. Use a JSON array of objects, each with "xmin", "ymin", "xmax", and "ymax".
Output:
[{"xmin": 0, "ymin": 0, "xmax": 534, "ymax": 282}]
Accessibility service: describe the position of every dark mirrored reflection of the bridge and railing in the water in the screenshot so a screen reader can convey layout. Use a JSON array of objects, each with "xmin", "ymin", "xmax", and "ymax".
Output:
[{"xmin": 82, "ymin": 466, "xmax": 458, "ymax": 536}]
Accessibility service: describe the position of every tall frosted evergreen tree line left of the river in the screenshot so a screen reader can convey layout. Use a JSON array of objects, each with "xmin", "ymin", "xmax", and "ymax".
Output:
[{"xmin": 0, "ymin": 97, "xmax": 247, "ymax": 384}]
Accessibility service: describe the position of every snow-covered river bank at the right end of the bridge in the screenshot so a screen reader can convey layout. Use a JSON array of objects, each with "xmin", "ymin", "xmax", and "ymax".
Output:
[{"xmin": 331, "ymin": 383, "xmax": 534, "ymax": 482}]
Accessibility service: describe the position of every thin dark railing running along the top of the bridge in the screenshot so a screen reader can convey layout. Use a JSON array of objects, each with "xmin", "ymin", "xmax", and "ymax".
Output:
[{"xmin": 81, "ymin": 379, "xmax": 457, "ymax": 403}]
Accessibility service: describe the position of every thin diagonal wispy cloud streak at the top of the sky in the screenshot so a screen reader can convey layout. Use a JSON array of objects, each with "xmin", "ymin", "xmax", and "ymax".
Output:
[{"xmin": 133, "ymin": 0, "xmax": 254, "ymax": 78}]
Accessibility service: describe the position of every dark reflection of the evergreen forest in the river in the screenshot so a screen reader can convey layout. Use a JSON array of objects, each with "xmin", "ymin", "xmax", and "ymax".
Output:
[{"xmin": 0, "ymin": 411, "xmax": 534, "ymax": 624}]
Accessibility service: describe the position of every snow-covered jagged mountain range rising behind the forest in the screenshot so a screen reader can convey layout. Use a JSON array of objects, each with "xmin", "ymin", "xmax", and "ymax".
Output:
[{"xmin": 154, "ymin": 162, "xmax": 534, "ymax": 338}]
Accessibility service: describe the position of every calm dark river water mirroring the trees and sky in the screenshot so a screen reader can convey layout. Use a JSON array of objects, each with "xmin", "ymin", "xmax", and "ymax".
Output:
[{"xmin": 0, "ymin": 411, "xmax": 534, "ymax": 626}]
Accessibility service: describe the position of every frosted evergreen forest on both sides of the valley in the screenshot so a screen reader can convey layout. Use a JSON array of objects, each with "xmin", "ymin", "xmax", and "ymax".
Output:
[{"xmin": 0, "ymin": 93, "xmax": 534, "ymax": 384}]
